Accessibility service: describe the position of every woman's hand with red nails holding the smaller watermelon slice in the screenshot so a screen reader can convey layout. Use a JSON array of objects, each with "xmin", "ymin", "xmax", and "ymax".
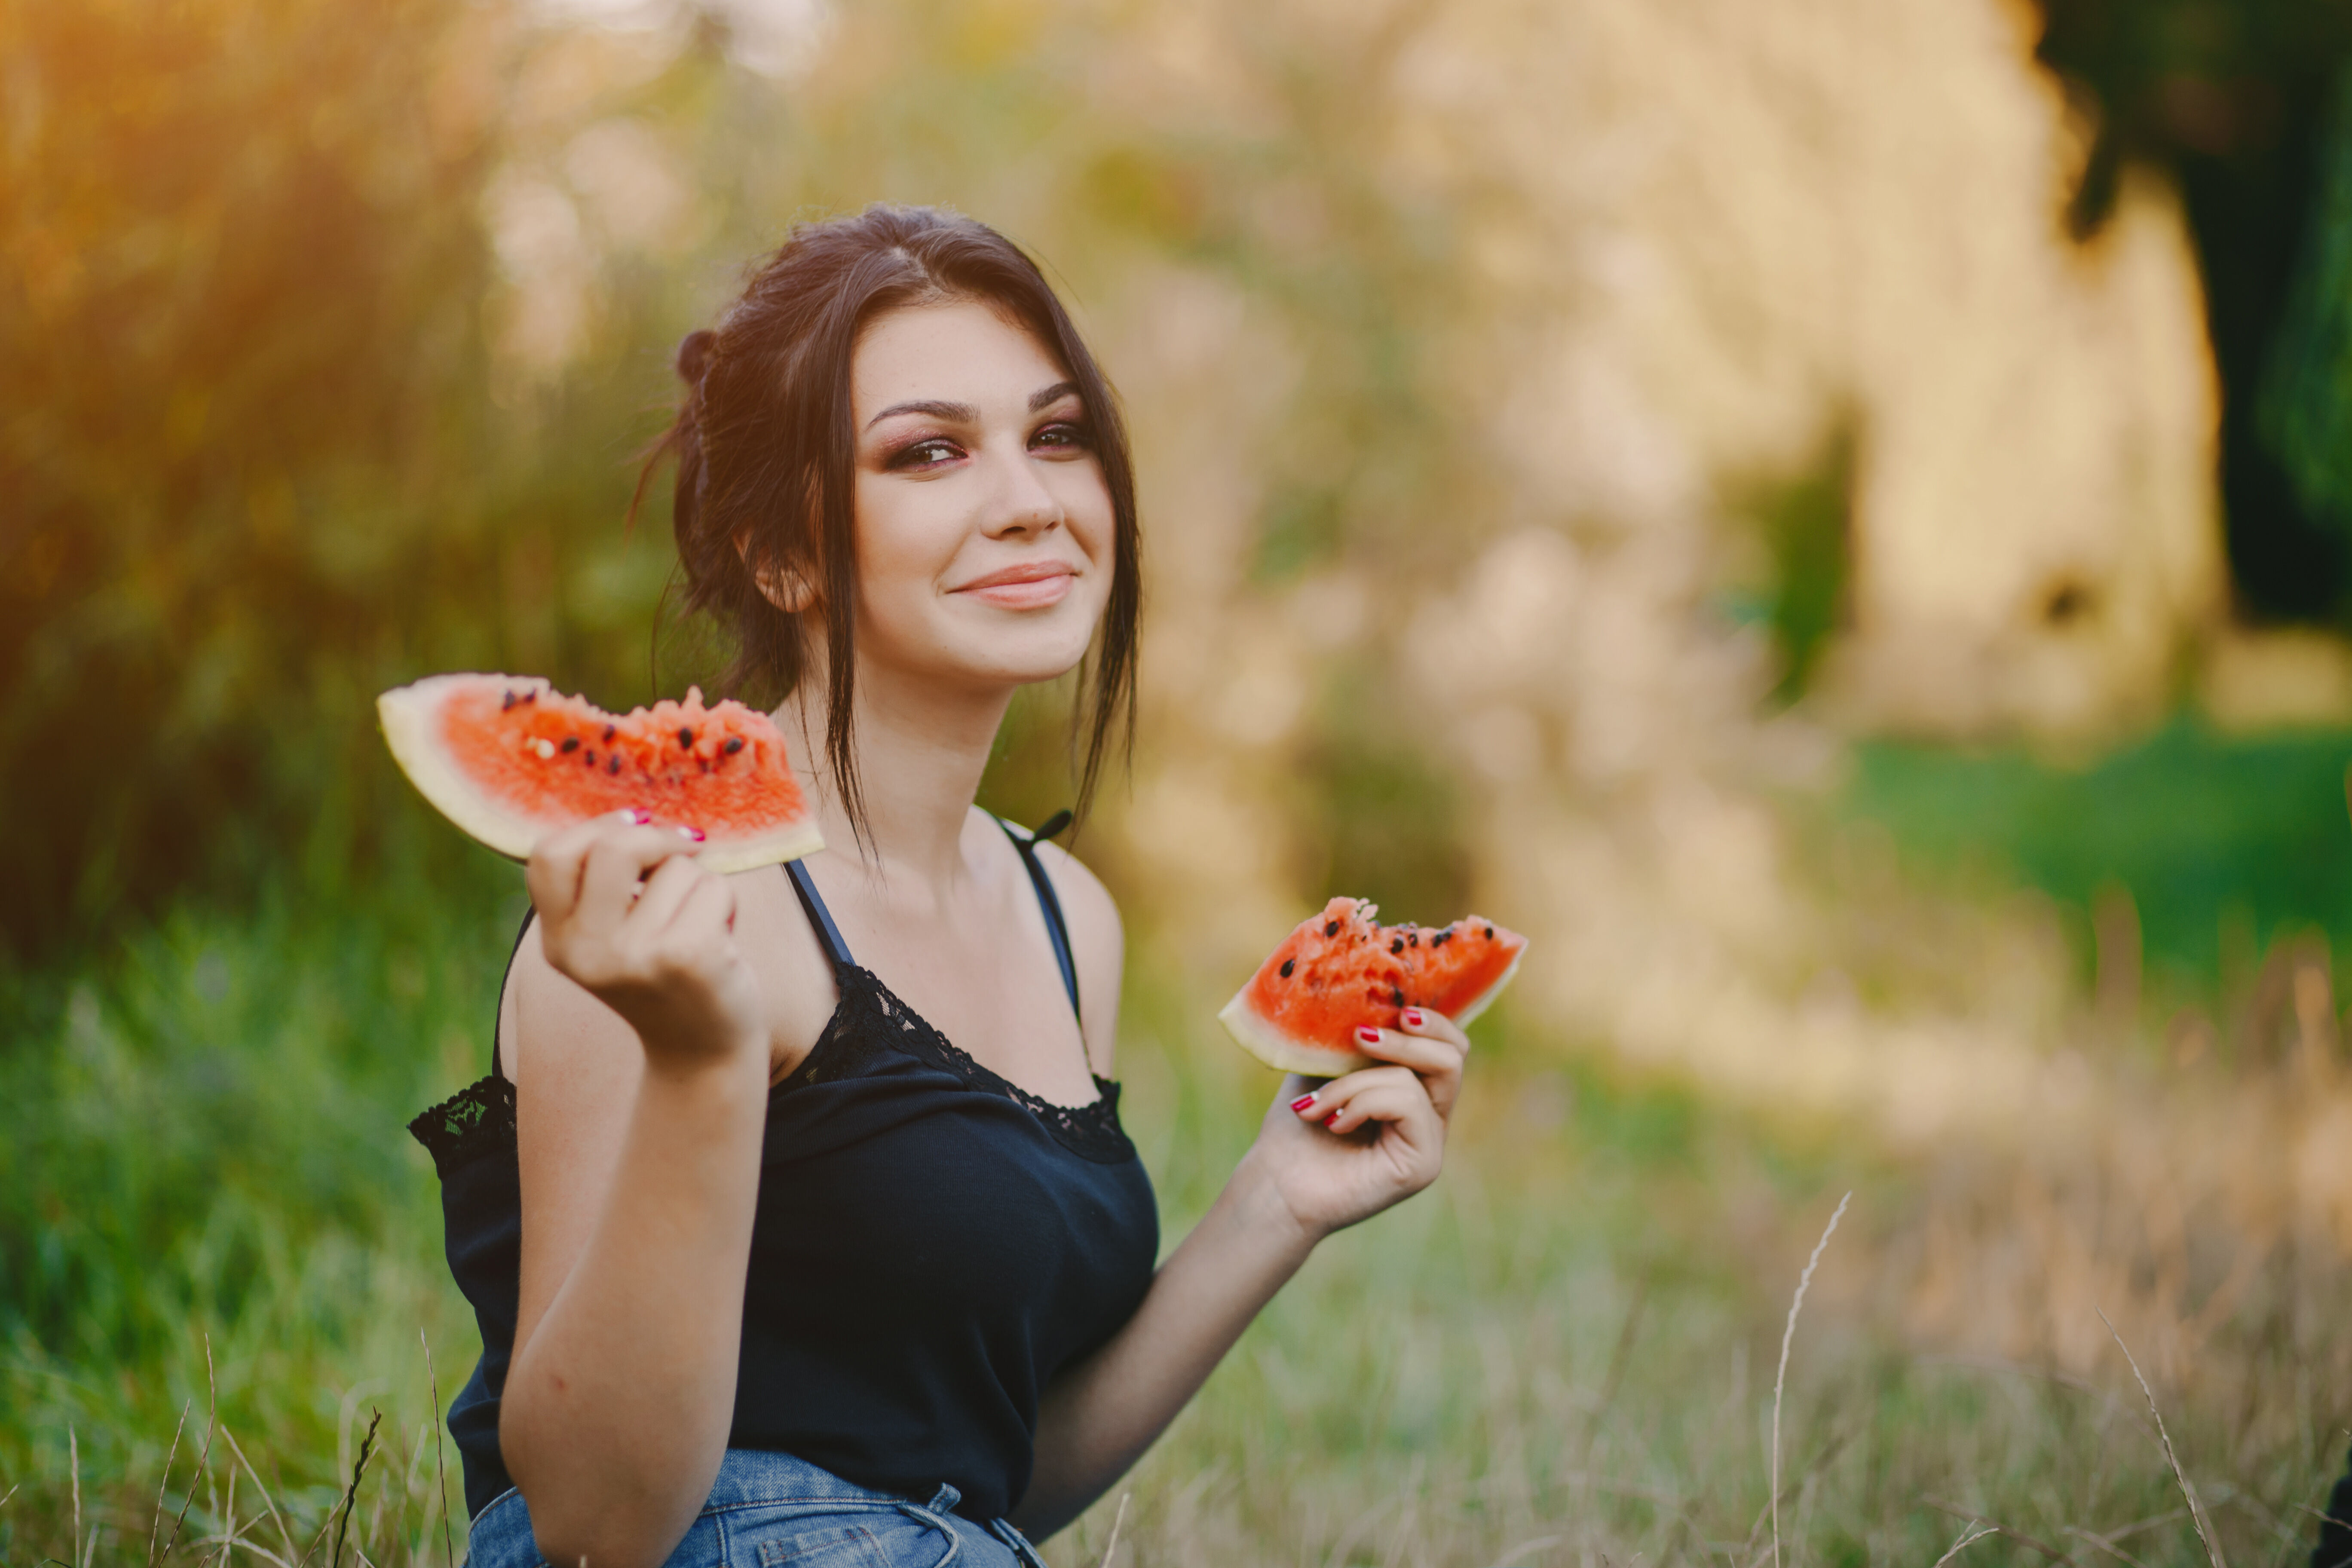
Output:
[{"xmin": 1249, "ymin": 1008, "xmax": 1470, "ymax": 1239}]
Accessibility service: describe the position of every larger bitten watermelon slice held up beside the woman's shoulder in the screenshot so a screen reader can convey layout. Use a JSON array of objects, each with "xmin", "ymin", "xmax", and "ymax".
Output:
[{"xmin": 377, "ymin": 675, "xmax": 826, "ymax": 872}]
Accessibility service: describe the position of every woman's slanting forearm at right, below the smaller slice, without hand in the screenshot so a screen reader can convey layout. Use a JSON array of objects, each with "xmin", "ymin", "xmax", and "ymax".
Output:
[{"xmin": 1014, "ymin": 1159, "xmax": 1317, "ymax": 1540}]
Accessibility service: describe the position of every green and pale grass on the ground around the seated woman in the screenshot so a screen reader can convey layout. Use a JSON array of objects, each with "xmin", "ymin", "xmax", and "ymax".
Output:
[{"xmin": 0, "ymin": 867, "xmax": 2352, "ymax": 1568}]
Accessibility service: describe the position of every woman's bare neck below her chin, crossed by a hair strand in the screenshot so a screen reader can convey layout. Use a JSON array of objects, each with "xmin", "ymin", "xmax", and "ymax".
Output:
[{"xmin": 776, "ymin": 665, "xmax": 1014, "ymax": 896}]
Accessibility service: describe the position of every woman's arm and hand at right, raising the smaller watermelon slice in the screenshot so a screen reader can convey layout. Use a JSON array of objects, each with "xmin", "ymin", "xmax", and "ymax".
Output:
[{"xmin": 1014, "ymin": 851, "xmax": 1470, "ymax": 1540}]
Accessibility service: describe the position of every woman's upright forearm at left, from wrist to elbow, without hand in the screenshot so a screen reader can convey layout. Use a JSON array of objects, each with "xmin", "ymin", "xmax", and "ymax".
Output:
[{"xmin": 499, "ymin": 1053, "xmax": 767, "ymax": 1568}]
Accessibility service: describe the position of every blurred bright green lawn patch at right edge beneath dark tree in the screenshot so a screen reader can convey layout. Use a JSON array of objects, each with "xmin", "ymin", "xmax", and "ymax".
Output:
[{"xmin": 1844, "ymin": 720, "xmax": 2352, "ymax": 990}]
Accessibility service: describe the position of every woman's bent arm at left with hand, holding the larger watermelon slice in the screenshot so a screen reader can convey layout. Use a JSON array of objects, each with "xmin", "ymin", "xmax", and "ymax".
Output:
[{"xmin": 499, "ymin": 823, "xmax": 828, "ymax": 1568}]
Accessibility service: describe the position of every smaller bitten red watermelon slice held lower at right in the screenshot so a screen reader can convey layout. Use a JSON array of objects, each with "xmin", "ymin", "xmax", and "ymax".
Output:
[{"xmin": 1216, "ymin": 898, "xmax": 1526, "ymax": 1079}]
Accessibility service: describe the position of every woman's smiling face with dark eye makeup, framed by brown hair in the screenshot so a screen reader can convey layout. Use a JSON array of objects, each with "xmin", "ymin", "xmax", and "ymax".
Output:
[{"xmin": 849, "ymin": 303, "xmax": 1112, "ymax": 686}]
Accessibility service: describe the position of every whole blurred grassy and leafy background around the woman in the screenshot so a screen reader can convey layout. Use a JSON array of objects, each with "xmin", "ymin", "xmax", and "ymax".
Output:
[{"xmin": 14, "ymin": 0, "xmax": 2352, "ymax": 1568}]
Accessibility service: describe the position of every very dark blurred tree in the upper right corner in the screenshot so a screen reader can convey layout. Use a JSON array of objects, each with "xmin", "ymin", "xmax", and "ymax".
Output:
[{"xmin": 2037, "ymin": 0, "xmax": 2352, "ymax": 621}]
